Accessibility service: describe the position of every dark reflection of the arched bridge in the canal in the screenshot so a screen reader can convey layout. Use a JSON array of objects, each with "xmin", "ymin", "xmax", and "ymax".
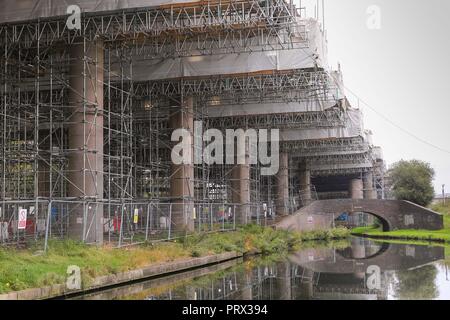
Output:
[{"xmin": 289, "ymin": 239, "xmax": 444, "ymax": 274}]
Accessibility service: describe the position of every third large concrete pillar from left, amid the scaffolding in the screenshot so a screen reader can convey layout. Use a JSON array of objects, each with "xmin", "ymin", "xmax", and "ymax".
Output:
[{"xmin": 231, "ymin": 164, "xmax": 251, "ymax": 224}]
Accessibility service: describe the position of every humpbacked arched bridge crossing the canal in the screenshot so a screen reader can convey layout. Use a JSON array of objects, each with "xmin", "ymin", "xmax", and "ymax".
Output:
[{"xmin": 275, "ymin": 199, "xmax": 444, "ymax": 231}]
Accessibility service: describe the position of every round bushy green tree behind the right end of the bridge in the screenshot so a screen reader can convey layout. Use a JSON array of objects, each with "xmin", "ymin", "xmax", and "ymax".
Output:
[{"xmin": 388, "ymin": 160, "xmax": 434, "ymax": 206}]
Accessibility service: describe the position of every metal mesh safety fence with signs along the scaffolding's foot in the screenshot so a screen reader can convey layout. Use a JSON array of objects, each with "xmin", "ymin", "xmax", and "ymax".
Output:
[{"xmin": 0, "ymin": 199, "xmax": 275, "ymax": 250}]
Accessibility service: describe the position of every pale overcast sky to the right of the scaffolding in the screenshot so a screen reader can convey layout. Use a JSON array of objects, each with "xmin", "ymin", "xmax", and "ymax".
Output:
[{"xmin": 295, "ymin": 0, "xmax": 450, "ymax": 193}]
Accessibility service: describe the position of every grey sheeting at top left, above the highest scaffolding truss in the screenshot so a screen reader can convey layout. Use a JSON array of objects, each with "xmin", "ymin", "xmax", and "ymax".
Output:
[{"xmin": 0, "ymin": 0, "xmax": 192, "ymax": 23}]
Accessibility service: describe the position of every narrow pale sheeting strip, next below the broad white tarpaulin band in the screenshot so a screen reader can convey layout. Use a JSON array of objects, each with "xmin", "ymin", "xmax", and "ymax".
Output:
[{"xmin": 205, "ymin": 100, "xmax": 336, "ymax": 118}]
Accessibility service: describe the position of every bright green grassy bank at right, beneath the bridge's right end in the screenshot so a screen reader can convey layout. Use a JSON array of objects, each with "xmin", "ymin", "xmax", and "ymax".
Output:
[{"xmin": 352, "ymin": 203, "xmax": 450, "ymax": 244}]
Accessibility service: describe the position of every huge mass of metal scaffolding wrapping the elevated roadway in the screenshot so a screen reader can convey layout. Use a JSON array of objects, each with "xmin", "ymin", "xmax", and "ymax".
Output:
[{"xmin": 0, "ymin": 0, "xmax": 383, "ymax": 249}]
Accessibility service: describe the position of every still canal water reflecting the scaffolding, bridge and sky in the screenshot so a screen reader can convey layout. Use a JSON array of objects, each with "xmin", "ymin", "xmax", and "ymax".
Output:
[{"xmin": 75, "ymin": 238, "xmax": 450, "ymax": 300}]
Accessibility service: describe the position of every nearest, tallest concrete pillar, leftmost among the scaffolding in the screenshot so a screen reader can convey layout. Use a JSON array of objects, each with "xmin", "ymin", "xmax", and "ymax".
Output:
[{"xmin": 68, "ymin": 41, "xmax": 104, "ymax": 243}]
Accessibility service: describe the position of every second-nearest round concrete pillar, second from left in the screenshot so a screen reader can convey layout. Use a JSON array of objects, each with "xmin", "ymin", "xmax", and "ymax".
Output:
[{"xmin": 169, "ymin": 97, "xmax": 195, "ymax": 231}]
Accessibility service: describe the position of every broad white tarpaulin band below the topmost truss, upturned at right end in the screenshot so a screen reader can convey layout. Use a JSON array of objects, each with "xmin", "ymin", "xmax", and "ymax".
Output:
[{"xmin": 125, "ymin": 19, "xmax": 328, "ymax": 81}]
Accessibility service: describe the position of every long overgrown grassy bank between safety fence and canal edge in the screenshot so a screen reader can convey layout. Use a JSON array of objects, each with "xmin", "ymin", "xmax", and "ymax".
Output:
[{"xmin": 0, "ymin": 226, "xmax": 349, "ymax": 293}]
